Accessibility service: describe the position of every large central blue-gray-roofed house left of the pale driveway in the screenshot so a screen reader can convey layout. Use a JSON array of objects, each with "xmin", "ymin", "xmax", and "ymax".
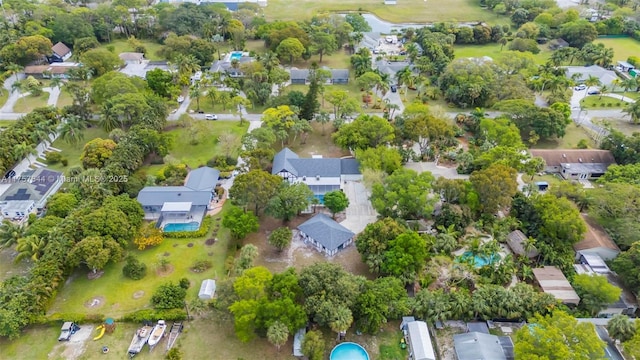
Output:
[{"xmin": 271, "ymin": 148, "xmax": 362, "ymax": 201}]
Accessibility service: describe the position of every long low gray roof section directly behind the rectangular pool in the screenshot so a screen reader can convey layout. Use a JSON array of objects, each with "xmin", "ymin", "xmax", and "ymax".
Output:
[{"xmin": 138, "ymin": 186, "xmax": 211, "ymax": 206}]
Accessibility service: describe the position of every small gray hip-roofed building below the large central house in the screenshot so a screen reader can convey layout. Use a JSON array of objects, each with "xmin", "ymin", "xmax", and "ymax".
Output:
[{"xmin": 298, "ymin": 213, "xmax": 356, "ymax": 256}]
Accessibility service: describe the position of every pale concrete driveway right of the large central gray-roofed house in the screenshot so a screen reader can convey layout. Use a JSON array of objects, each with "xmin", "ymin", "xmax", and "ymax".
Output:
[{"xmin": 340, "ymin": 181, "xmax": 378, "ymax": 234}]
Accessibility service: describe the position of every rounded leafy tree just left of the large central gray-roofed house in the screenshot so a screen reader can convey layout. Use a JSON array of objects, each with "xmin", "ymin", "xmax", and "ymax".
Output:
[{"xmin": 229, "ymin": 170, "xmax": 282, "ymax": 214}]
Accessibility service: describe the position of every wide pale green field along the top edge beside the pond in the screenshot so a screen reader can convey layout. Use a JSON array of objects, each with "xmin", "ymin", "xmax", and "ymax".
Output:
[{"xmin": 264, "ymin": 0, "xmax": 508, "ymax": 24}]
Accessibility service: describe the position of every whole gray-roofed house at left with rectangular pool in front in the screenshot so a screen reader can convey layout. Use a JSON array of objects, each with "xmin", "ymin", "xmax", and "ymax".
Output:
[{"xmin": 138, "ymin": 167, "xmax": 220, "ymax": 227}]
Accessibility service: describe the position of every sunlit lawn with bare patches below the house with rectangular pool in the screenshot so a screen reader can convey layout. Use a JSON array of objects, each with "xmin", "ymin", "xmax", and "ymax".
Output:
[{"xmin": 49, "ymin": 205, "xmax": 229, "ymax": 318}]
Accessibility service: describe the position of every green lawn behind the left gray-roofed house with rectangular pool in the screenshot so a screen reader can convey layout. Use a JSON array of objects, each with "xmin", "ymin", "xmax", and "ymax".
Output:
[{"xmin": 162, "ymin": 120, "xmax": 249, "ymax": 169}]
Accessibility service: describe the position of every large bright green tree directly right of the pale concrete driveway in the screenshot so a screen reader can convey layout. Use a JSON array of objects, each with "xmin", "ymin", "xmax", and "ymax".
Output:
[{"xmin": 371, "ymin": 169, "xmax": 435, "ymax": 220}]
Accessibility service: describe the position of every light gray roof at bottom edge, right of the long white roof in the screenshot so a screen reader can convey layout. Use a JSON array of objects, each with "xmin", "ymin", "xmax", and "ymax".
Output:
[{"xmin": 453, "ymin": 332, "xmax": 507, "ymax": 360}]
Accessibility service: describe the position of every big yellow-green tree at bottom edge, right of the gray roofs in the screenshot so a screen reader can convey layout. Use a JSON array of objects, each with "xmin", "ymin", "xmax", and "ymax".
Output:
[{"xmin": 515, "ymin": 311, "xmax": 605, "ymax": 360}]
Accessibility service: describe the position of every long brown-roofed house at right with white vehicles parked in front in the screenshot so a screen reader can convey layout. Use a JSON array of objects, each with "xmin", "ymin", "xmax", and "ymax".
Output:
[{"xmin": 529, "ymin": 149, "xmax": 616, "ymax": 180}]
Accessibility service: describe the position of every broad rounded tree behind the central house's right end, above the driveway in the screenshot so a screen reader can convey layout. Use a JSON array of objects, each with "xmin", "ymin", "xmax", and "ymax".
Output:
[{"xmin": 332, "ymin": 115, "xmax": 395, "ymax": 150}]
